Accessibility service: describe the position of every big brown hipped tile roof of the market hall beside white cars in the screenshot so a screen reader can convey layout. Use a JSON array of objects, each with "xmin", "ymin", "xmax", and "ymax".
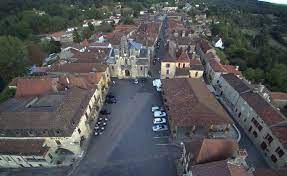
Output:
[{"xmin": 162, "ymin": 78, "xmax": 233, "ymax": 126}]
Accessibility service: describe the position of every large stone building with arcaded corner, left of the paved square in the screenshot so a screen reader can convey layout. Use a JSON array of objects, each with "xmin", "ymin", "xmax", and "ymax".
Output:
[{"xmin": 0, "ymin": 67, "xmax": 110, "ymax": 168}]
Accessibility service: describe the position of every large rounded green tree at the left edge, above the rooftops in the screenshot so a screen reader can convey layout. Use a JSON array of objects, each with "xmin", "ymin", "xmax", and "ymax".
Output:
[{"xmin": 0, "ymin": 36, "xmax": 28, "ymax": 83}]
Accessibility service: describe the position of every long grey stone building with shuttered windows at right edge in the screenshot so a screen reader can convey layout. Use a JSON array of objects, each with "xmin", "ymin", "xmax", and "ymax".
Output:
[{"xmin": 214, "ymin": 74, "xmax": 287, "ymax": 168}]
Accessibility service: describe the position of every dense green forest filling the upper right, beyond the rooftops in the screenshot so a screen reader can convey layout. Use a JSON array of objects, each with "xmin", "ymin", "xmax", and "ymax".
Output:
[{"xmin": 189, "ymin": 0, "xmax": 287, "ymax": 92}]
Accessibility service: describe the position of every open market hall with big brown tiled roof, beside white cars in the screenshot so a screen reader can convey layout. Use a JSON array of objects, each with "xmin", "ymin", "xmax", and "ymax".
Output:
[{"xmin": 162, "ymin": 78, "xmax": 238, "ymax": 139}]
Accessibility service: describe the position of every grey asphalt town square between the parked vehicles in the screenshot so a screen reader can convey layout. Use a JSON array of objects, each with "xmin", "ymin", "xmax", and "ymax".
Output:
[{"xmin": 1, "ymin": 80, "xmax": 180, "ymax": 176}]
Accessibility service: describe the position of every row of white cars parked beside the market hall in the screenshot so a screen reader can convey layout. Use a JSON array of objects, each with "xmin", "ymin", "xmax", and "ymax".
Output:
[{"xmin": 151, "ymin": 106, "xmax": 168, "ymax": 132}]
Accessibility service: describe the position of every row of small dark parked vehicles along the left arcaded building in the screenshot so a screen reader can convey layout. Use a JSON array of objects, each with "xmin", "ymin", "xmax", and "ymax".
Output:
[{"xmin": 94, "ymin": 93, "xmax": 117, "ymax": 136}]
